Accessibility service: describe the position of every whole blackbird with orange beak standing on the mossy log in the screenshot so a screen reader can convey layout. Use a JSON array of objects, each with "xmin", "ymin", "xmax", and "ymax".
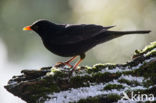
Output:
[{"xmin": 23, "ymin": 20, "xmax": 150, "ymax": 69}]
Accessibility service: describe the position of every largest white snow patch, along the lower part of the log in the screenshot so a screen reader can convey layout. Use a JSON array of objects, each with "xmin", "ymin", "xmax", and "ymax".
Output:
[{"xmin": 45, "ymin": 80, "xmax": 147, "ymax": 103}]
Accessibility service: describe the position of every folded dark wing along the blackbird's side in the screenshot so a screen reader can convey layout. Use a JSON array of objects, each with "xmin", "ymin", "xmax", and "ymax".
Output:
[{"xmin": 51, "ymin": 24, "xmax": 113, "ymax": 45}]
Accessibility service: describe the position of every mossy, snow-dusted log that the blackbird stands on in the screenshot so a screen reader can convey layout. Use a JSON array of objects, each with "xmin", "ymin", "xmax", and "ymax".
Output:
[{"xmin": 5, "ymin": 42, "xmax": 156, "ymax": 103}]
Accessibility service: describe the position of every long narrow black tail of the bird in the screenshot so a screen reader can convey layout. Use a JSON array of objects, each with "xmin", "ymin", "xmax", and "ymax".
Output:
[{"xmin": 109, "ymin": 30, "xmax": 151, "ymax": 35}]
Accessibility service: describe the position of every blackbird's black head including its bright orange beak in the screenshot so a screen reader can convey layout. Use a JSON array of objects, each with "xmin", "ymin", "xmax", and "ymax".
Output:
[{"xmin": 23, "ymin": 20, "xmax": 57, "ymax": 37}]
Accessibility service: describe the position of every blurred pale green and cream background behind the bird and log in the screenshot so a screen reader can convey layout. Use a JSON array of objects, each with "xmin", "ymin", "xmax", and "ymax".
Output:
[{"xmin": 0, "ymin": 0, "xmax": 156, "ymax": 103}]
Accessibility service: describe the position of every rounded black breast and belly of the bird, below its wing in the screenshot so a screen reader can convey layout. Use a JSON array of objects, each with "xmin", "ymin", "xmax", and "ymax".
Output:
[{"xmin": 43, "ymin": 40, "xmax": 95, "ymax": 57}]
